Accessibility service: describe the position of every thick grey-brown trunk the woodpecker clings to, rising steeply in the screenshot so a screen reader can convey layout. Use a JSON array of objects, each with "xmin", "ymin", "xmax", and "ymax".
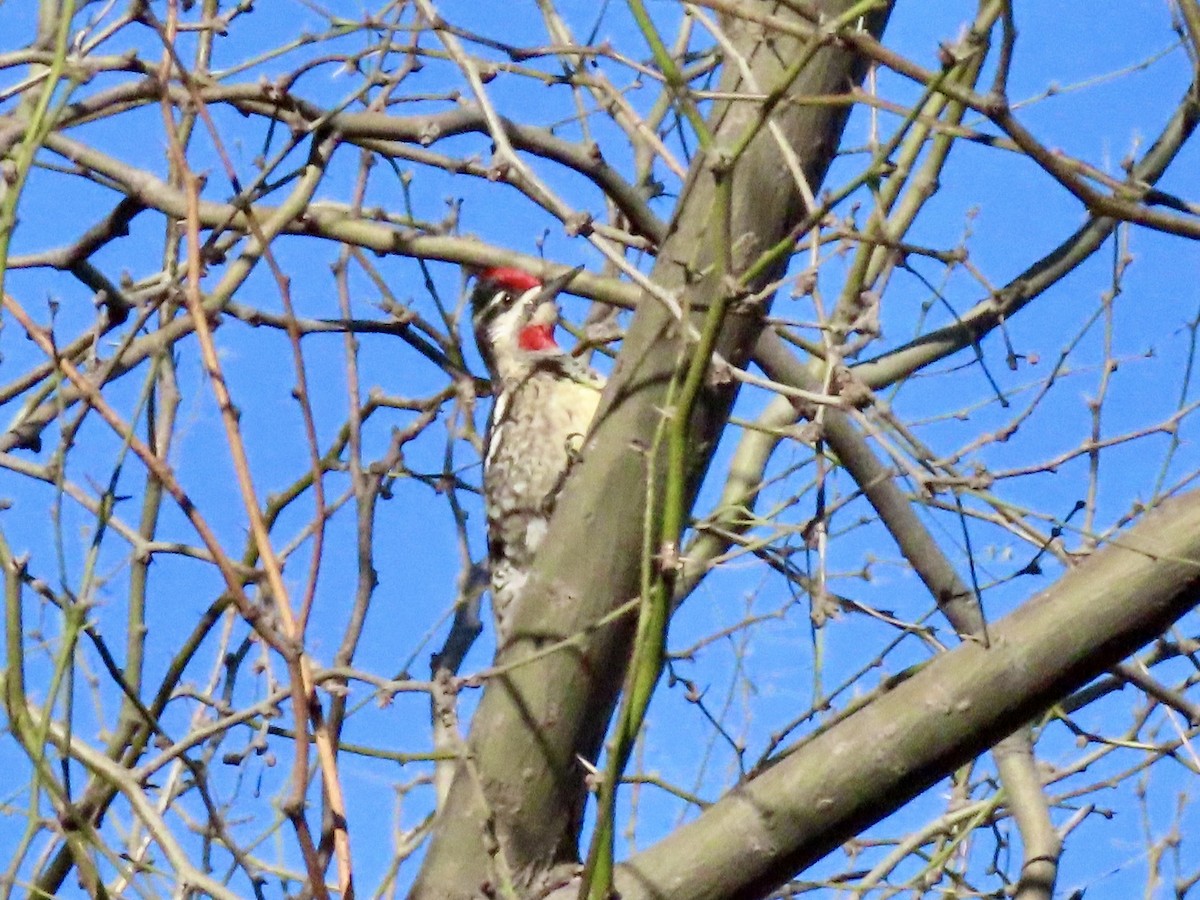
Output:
[{"xmin": 412, "ymin": 0, "xmax": 887, "ymax": 900}]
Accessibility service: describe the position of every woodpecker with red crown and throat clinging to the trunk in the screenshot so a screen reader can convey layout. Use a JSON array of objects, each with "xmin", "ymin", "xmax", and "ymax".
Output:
[{"xmin": 472, "ymin": 266, "xmax": 604, "ymax": 647}]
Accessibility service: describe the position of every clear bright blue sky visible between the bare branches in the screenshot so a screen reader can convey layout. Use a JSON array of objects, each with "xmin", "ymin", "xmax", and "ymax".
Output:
[{"xmin": 0, "ymin": 0, "xmax": 1200, "ymax": 898}]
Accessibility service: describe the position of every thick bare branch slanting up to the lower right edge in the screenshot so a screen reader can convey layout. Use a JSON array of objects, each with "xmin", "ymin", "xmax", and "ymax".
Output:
[{"xmin": 554, "ymin": 492, "xmax": 1200, "ymax": 900}]
